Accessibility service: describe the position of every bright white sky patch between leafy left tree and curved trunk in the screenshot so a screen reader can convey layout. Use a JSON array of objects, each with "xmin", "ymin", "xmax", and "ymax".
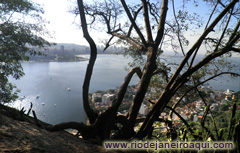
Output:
[{"xmin": 34, "ymin": 0, "xmax": 87, "ymax": 45}]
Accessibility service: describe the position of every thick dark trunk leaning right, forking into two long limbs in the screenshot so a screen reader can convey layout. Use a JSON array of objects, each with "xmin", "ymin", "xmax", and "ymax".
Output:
[{"xmin": 138, "ymin": 14, "xmax": 240, "ymax": 138}]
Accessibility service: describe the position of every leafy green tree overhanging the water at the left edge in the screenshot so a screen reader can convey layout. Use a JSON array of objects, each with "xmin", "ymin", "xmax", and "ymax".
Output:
[{"xmin": 0, "ymin": 0, "xmax": 50, "ymax": 103}]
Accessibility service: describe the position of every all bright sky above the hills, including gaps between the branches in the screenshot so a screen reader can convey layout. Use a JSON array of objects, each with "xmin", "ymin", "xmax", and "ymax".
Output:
[{"xmin": 33, "ymin": 0, "xmax": 239, "ymax": 56}]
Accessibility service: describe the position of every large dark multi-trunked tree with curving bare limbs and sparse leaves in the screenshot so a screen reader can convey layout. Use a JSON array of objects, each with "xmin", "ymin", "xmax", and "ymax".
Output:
[{"xmin": 50, "ymin": 0, "xmax": 240, "ymax": 143}]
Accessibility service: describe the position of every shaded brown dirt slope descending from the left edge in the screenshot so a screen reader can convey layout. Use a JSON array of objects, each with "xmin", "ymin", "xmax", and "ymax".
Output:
[{"xmin": 0, "ymin": 105, "xmax": 116, "ymax": 153}]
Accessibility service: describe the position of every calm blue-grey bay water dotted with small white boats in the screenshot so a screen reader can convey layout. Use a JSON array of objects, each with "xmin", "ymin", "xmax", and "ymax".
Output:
[{"xmin": 8, "ymin": 55, "xmax": 240, "ymax": 124}]
